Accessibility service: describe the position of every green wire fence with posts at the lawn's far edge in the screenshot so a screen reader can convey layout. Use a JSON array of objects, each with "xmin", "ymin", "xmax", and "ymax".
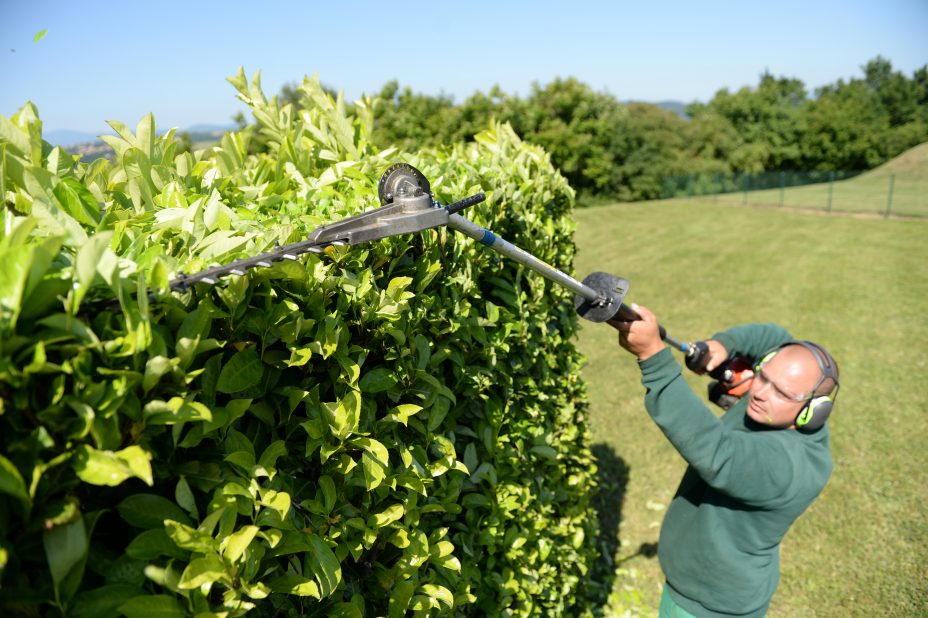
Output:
[{"xmin": 662, "ymin": 169, "xmax": 928, "ymax": 218}]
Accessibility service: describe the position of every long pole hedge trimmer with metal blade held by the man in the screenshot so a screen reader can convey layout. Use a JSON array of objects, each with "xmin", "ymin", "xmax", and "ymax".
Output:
[{"xmin": 163, "ymin": 163, "xmax": 753, "ymax": 409}]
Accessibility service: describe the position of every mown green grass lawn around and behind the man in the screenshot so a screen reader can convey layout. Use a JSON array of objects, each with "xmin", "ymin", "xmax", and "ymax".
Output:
[{"xmin": 576, "ymin": 198, "xmax": 928, "ymax": 616}]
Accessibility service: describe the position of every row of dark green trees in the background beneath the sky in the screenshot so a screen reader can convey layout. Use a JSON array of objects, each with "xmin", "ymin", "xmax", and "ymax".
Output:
[{"xmin": 270, "ymin": 56, "xmax": 928, "ymax": 200}]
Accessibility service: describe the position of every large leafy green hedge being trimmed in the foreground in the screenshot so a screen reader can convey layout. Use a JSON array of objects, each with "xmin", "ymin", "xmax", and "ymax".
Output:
[{"xmin": 0, "ymin": 71, "xmax": 597, "ymax": 618}]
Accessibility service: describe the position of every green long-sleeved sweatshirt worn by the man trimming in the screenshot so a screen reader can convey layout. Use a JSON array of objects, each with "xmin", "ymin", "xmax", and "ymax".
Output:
[{"xmin": 640, "ymin": 324, "xmax": 832, "ymax": 617}]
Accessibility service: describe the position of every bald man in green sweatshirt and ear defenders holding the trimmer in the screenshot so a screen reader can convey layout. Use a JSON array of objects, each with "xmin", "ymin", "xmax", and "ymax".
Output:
[{"xmin": 610, "ymin": 305, "xmax": 838, "ymax": 618}]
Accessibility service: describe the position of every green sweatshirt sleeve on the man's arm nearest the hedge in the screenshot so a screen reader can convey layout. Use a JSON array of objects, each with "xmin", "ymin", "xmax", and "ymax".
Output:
[{"xmin": 640, "ymin": 346, "xmax": 798, "ymax": 507}]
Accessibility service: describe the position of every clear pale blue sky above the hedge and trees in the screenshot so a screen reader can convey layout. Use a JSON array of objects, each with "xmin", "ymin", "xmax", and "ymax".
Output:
[{"xmin": 0, "ymin": 0, "xmax": 928, "ymax": 133}]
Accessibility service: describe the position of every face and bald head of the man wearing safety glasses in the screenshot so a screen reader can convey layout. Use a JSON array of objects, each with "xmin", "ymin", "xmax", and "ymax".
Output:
[{"xmin": 747, "ymin": 346, "xmax": 821, "ymax": 429}]
